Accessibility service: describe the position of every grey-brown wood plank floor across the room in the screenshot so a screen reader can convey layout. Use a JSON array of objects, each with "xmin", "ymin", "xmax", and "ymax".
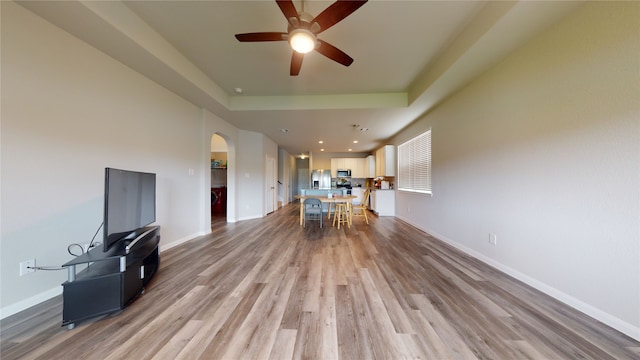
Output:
[{"xmin": 0, "ymin": 205, "xmax": 640, "ymax": 360}]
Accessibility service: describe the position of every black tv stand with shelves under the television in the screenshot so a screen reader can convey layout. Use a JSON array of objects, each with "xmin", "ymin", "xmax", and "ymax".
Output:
[{"xmin": 62, "ymin": 226, "xmax": 160, "ymax": 329}]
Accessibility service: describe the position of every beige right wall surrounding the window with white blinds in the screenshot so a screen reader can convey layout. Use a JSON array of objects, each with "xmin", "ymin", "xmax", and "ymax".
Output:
[{"xmin": 394, "ymin": 2, "xmax": 640, "ymax": 338}]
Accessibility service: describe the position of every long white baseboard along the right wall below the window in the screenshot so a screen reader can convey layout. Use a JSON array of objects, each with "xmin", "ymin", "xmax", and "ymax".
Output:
[{"xmin": 397, "ymin": 216, "xmax": 640, "ymax": 341}]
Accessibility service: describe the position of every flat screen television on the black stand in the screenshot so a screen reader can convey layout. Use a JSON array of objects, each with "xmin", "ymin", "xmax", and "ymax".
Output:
[{"xmin": 103, "ymin": 168, "xmax": 156, "ymax": 252}]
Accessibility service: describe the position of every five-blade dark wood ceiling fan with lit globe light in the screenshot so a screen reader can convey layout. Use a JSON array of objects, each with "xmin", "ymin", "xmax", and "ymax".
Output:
[{"xmin": 236, "ymin": 0, "xmax": 367, "ymax": 76}]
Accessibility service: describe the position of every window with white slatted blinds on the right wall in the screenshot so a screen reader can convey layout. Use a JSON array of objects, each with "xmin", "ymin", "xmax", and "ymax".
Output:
[{"xmin": 398, "ymin": 129, "xmax": 431, "ymax": 194}]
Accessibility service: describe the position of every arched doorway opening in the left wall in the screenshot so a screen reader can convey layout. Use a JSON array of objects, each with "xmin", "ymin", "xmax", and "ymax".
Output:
[{"xmin": 211, "ymin": 134, "xmax": 229, "ymax": 222}]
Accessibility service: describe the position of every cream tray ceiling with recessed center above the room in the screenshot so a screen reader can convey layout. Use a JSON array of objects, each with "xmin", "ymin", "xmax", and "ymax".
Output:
[{"xmin": 19, "ymin": 0, "xmax": 581, "ymax": 155}]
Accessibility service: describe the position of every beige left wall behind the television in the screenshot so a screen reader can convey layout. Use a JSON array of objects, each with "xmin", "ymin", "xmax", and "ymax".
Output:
[{"xmin": 0, "ymin": 2, "xmax": 208, "ymax": 313}]
